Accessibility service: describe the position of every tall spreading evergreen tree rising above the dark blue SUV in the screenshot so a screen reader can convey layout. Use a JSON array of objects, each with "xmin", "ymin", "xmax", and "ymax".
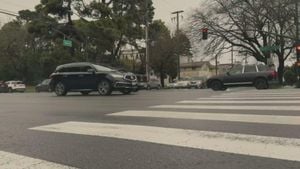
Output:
[{"xmin": 20, "ymin": 0, "xmax": 154, "ymax": 64}]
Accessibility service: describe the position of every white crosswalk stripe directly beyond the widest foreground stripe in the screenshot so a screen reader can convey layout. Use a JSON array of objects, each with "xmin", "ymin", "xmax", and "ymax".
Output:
[{"xmin": 108, "ymin": 110, "xmax": 300, "ymax": 125}]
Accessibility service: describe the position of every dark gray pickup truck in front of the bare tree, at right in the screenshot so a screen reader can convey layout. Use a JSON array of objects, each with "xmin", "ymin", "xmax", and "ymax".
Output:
[{"xmin": 207, "ymin": 65, "xmax": 278, "ymax": 91}]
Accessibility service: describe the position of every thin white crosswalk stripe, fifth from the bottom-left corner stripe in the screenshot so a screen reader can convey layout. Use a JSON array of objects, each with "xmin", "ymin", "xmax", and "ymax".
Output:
[{"xmin": 177, "ymin": 100, "xmax": 300, "ymax": 104}]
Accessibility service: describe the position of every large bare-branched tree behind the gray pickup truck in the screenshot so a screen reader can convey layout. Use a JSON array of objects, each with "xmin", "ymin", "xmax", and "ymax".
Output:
[{"xmin": 191, "ymin": 0, "xmax": 295, "ymax": 83}]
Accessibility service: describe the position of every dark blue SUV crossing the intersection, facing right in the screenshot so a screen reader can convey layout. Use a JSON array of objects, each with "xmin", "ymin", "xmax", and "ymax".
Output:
[{"xmin": 50, "ymin": 62, "xmax": 137, "ymax": 96}]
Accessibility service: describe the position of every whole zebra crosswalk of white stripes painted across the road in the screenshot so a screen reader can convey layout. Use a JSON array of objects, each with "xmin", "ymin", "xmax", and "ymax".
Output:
[{"xmin": 0, "ymin": 89, "xmax": 300, "ymax": 169}]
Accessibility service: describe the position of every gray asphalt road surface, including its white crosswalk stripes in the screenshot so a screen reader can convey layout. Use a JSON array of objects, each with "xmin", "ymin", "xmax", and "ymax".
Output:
[{"xmin": 0, "ymin": 88, "xmax": 300, "ymax": 169}]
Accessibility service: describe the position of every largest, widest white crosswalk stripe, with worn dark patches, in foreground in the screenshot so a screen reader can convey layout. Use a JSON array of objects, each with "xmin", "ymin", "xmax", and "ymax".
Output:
[{"xmin": 31, "ymin": 122, "xmax": 300, "ymax": 161}]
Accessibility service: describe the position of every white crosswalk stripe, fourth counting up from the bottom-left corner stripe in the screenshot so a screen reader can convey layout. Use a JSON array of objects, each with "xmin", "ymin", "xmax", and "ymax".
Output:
[{"xmin": 150, "ymin": 105, "xmax": 300, "ymax": 111}]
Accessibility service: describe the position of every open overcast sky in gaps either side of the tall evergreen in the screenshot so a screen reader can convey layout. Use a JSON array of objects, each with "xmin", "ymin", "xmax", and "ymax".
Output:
[{"xmin": 0, "ymin": 0, "xmax": 201, "ymax": 29}]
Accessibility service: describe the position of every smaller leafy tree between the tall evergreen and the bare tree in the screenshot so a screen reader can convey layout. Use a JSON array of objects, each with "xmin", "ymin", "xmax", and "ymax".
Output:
[{"xmin": 149, "ymin": 20, "xmax": 191, "ymax": 86}]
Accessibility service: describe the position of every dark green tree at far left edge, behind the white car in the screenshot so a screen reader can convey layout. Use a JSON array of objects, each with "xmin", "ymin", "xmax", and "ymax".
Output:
[{"xmin": 0, "ymin": 21, "xmax": 39, "ymax": 82}]
